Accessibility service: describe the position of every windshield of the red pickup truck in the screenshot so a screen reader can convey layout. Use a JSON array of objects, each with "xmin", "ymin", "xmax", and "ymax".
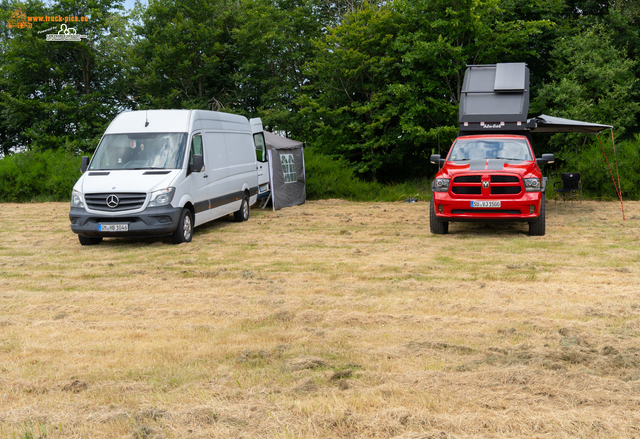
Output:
[{"xmin": 449, "ymin": 139, "xmax": 533, "ymax": 162}]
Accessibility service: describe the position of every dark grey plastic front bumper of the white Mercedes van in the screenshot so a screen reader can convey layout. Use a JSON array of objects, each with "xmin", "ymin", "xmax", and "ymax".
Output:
[{"xmin": 69, "ymin": 206, "xmax": 182, "ymax": 238}]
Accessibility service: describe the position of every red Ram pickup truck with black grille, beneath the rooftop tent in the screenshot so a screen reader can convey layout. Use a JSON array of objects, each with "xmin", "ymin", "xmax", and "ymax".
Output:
[{"xmin": 430, "ymin": 134, "xmax": 554, "ymax": 235}]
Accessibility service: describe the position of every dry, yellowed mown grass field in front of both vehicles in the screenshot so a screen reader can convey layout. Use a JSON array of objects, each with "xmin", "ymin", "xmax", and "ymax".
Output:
[{"xmin": 0, "ymin": 200, "xmax": 640, "ymax": 439}]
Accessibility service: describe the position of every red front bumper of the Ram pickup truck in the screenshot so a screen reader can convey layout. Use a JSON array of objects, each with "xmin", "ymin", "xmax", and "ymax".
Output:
[{"xmin": 433, "ymin": 192, "xmax": 544, "ymax": 223}]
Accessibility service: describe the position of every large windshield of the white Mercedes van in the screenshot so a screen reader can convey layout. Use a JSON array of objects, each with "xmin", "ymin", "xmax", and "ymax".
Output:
[{"xmin": 89, "ymin": 133, "xmax": 187, "ymax": 170}]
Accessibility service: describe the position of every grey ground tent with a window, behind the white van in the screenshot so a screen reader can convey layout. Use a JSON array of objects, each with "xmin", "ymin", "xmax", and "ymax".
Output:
[{"xmin": 264, "ymin": 131, "xmax": 307, "ymax": 210}]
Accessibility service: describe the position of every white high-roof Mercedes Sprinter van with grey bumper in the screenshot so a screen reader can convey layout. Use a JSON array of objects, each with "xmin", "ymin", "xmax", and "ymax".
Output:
[{"xmin": 69, "ymin": 110, "xmax": 258, "ymax": 245}]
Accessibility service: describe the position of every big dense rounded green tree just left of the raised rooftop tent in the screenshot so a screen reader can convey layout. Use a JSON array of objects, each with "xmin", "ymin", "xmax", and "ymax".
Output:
[{"xmin": 296, "ymin": 0, "xmax": 551, "ymax": 181}]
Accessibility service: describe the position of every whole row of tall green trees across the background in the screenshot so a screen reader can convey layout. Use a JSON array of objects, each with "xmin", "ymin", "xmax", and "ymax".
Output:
[{"xmin": 0, "ymin": 0, "xmax": 640, "ymax": 196}]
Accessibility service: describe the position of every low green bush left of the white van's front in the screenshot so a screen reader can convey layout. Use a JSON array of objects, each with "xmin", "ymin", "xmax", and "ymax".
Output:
[{"xmin": 0, "ymin": 151, "xmax": 81, "ymax": 202}]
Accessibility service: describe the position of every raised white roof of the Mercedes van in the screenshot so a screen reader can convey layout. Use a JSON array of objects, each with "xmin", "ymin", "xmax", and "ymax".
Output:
[{"xmin": 105, "ymin": 110, "xmax": 250, "ymax": 134}]
